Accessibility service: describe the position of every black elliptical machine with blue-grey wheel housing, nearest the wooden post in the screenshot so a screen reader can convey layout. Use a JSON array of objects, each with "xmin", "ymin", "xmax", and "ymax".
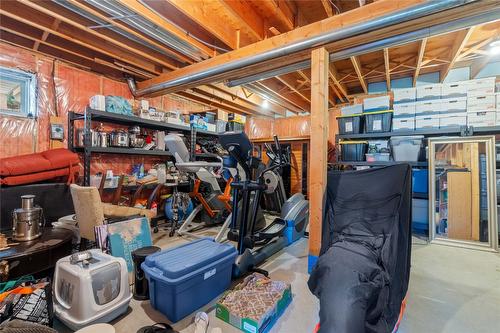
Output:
[{"xmin": 219, "ymin": 132, "xmax": 309, "ymax": 278}]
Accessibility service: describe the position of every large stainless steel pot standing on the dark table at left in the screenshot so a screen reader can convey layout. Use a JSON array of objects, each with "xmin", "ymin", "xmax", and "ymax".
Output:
[{"xmin": 12, "ymin": 195, "xmax": 43, "ymax": 242}]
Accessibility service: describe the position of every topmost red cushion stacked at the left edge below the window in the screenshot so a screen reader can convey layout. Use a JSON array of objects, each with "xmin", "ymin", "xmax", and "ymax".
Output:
[{"xmin": 0, "ymin": 154, "xmax": 52, "ymax": 176}]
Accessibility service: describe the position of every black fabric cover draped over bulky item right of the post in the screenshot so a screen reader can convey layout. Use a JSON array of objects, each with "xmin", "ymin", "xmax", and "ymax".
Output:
[{"xmin": 308, "ymin": 164, "xmax": 412, "ymax": 333}]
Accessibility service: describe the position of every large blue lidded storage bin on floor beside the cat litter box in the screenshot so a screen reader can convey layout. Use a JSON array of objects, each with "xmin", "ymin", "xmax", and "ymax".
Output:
[{"xmin": 141, "ymin": 238, "xmax": 238, "ymax": 322}]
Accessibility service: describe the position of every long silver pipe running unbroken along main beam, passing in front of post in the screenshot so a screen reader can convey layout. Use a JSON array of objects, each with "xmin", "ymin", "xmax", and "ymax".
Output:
[{"xmin": 127, "ymin": 0, "xmax": 478, "ymax": 97}]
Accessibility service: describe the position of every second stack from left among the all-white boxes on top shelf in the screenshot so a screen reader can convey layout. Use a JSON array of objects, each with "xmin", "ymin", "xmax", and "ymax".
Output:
[{"xmin": 415, "ymin": 84, "xmax": 442, "ymax": 130}]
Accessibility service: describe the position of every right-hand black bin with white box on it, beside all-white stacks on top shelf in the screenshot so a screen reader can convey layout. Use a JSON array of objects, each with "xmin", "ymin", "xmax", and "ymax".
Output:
[{"xmin": 363, "ymin": 96, "xmax": 393, "ymax": 133}]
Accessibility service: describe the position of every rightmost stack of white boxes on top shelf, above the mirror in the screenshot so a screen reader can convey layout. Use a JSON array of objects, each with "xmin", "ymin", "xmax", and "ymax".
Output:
[{"xmin": 467, "ymin": 77, "xmax": 497, "ymax": 127}]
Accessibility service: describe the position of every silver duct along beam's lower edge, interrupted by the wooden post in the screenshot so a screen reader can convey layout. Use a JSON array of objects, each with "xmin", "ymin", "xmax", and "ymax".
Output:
[{"xmin": 226, "ymin": 8, "xmax": 500, "ymax": 87}]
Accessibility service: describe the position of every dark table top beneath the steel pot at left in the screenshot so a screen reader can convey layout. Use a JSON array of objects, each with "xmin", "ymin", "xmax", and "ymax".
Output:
[{"xmin": 0, "ymin": 228, "xmax": 73, "ymax": 260}]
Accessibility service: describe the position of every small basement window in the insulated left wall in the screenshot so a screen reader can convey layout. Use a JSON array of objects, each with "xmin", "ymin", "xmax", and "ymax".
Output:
[{"xmin": 0, "ymin": 67, "xmax": 36, "ymax": 118}]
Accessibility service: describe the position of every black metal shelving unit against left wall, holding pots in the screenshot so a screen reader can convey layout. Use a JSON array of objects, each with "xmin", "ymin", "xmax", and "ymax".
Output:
[{"xmin": 68, "ymin": 107, "xmax": 218, "ymax": 186}]
